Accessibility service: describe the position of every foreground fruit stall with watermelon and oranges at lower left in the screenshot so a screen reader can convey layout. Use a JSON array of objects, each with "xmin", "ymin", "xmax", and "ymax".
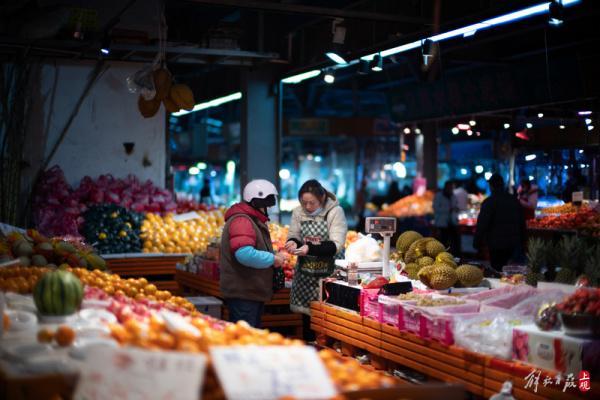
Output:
[{"xmin": 0, "ymin": 238, "xmax": 464, "ymax": 399}]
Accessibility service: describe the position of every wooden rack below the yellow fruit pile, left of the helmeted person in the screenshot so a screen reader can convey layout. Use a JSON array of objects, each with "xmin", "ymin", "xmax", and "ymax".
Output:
[{"xmin": 102, "ymin": 253, "xmax": 189, "ymax": 294}]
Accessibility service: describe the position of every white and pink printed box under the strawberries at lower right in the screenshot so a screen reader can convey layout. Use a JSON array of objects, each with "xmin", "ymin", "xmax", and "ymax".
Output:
[{"xmin": 513, "ymin": 324, "xmax": 600, "ymax": 376}]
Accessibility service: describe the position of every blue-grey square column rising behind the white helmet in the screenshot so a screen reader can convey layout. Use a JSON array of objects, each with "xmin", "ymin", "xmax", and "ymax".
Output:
[{"xmin": 240, "ymin": 68, "xmax": 281, "ymax": 188}]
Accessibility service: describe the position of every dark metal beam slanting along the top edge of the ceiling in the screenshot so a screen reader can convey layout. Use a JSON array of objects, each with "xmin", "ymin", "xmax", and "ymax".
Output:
[{"xmin": 182, "ymin": 0, "xmax": 429, "ymax": 25}]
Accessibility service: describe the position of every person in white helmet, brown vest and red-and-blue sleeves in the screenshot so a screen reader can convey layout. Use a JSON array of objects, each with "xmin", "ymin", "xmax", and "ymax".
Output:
[{"xmin": 220, "ymin": 179, "xmax": 285, "ymax": 328}]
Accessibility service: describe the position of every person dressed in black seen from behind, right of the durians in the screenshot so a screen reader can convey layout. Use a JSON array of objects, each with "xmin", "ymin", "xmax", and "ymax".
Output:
[{"xmin": 473, "ymin": 174, "xmax": 525, "ymax": 271}]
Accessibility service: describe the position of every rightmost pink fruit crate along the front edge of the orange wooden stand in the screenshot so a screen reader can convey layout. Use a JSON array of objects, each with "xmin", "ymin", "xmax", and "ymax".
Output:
[{"xmin": 419, "ymin": 301, "xmax": 479, "ymax": 346}]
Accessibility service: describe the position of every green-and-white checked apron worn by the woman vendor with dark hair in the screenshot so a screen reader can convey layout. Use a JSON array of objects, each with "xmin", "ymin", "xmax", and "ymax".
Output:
[{"xmin": 290, "ymin": 220, "xmax": 339, "ymax": 315}]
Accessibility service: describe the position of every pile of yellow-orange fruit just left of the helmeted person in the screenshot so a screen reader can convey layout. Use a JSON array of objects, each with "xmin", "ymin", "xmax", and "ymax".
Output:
[{"xmin": 140, "ymin": 209, "xmax": 225, "ymax": 254}]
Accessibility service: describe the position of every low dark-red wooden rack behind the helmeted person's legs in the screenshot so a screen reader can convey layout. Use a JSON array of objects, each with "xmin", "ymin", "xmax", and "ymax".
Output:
[{"xmin": 175, "ymin": 270, "xmax": 302, "ymax": 338}]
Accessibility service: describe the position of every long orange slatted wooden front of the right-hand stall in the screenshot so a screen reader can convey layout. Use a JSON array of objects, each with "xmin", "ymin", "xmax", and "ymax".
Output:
[{"xmin": 311, "ymin": 302, "xmax": 600, "ymax": 400}]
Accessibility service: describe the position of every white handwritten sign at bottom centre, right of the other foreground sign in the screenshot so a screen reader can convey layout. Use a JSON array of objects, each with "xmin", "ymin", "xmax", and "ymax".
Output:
[{"xmin": 210, "ymin": 346, "xmax": 336, "ymax": 400}]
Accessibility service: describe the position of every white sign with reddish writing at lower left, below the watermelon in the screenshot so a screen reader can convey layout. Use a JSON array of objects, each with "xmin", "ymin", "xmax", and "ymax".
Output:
[{"xmin": 74, "ymin": 347, "xmax": 207, "ymax": 400}]
